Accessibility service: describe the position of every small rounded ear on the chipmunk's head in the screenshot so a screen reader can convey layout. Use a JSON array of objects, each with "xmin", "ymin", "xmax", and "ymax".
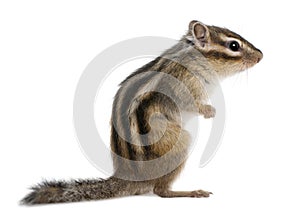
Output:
[{"xmin": 189, "ymin": 20, "xmax": 209, "ymax": 47}]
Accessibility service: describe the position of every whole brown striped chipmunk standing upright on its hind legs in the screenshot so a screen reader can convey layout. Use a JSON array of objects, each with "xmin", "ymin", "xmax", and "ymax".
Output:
[{"xmin": 21, "ymin": 20, "xmax": 263, "ymax": 205}]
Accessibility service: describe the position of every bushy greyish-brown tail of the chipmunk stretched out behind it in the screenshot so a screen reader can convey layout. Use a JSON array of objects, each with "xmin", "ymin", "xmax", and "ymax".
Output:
[{"xmin": 21, "ymin": 177, "xmax": 134, "ymax": 205}]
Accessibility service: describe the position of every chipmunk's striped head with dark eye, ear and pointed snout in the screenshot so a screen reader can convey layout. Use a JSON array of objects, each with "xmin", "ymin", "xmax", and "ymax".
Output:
[{"xmin": 186, "ymin": 21, "xmax": 263, "ymax": 77}]
